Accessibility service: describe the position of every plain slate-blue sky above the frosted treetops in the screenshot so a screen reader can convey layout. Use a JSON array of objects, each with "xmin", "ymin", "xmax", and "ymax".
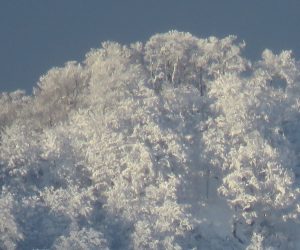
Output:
[{"xmin": 0, "ymin": 0, "xmax": 300, "ymax": 93}]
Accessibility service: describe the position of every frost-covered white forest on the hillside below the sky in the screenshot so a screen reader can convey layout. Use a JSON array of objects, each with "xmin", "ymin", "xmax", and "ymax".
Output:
[{"xmin": 0, "ymin": 31, "xmax": 300, "ymax": 250}]
